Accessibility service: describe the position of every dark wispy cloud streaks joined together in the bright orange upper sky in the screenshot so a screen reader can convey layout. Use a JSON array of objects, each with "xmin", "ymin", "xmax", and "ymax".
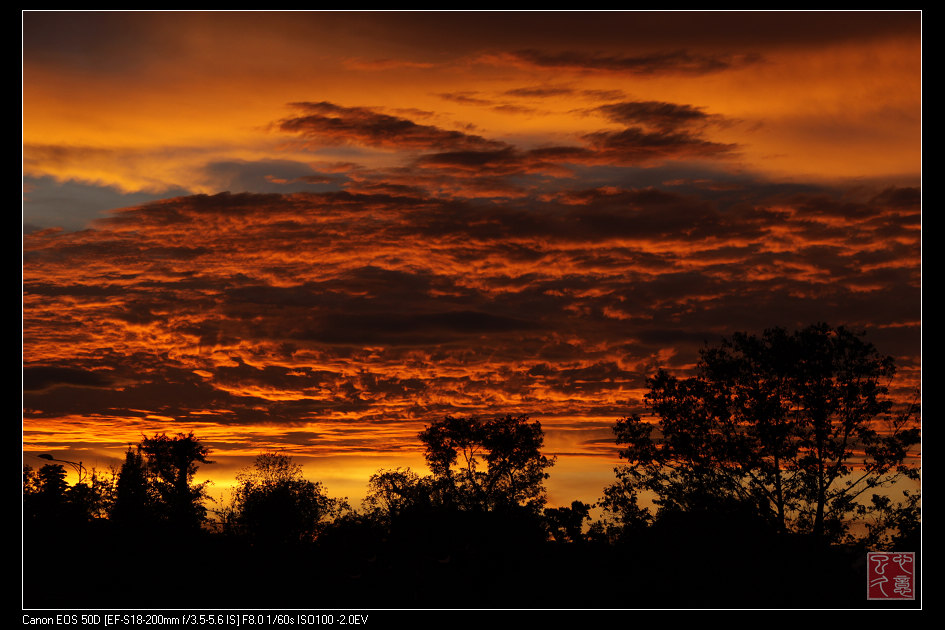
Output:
[{"xmin": 279, "ymin": 94, "xmax": 738, "ymax": 205}]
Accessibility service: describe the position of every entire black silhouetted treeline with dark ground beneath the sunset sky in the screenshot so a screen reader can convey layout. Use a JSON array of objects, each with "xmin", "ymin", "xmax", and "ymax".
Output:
[{"xmin": 23, "ymin": 325, "xmax": 921, "ymax": 609}]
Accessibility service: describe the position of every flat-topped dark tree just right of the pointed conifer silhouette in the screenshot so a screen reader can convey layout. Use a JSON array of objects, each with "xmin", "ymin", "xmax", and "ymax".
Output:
[{"xmin": 141, "ymin": 433, "xmax": 213, "ymax": 529}]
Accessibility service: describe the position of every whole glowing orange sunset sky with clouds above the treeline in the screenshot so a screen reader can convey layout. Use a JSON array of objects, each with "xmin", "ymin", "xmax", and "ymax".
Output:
[{"xmin": 22, "ymin": 11, "xmax": 922, "ymax": 504}]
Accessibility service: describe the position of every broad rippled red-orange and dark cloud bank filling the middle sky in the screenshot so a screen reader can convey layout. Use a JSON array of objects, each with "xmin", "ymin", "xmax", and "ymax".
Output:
[{"xmin": 23, "ymin": 177, "xmax": 920, "ymax": 460}]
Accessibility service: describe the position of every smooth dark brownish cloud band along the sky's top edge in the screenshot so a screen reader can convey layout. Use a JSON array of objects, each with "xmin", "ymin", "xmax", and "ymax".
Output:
[{"xmin": 23, "ymin": 11, "xmax": 922, "ymax": 77}]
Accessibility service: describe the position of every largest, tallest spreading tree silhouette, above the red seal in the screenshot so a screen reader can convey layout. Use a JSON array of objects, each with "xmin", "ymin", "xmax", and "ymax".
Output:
[{"xmin": 602, "ymin": 324, "xmax": 919, "ymax": 540}]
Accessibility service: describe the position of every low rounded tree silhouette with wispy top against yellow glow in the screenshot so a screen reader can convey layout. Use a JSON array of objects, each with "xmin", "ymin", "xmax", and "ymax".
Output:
[{"xmin": 228, "ymin": 452, "xmax": 343, "ymax": 543}]
